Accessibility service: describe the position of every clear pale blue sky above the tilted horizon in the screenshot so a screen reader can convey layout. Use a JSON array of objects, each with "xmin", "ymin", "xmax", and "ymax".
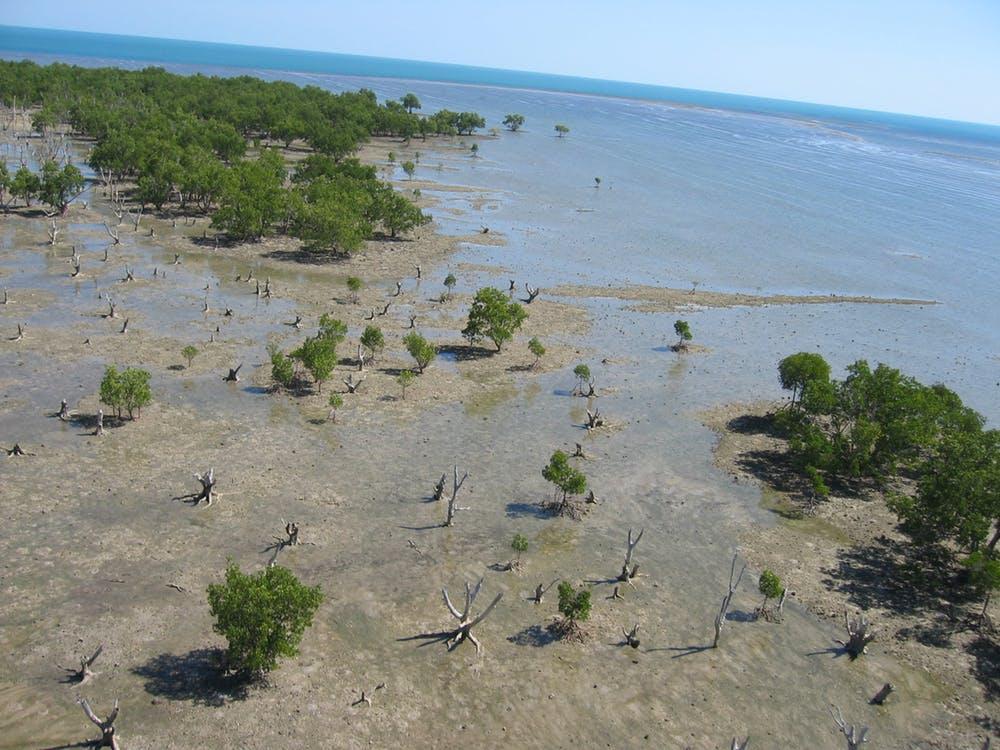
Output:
[{"xmin": 0, "ymin": 0, "xmax": 1000, "ymax": 124}]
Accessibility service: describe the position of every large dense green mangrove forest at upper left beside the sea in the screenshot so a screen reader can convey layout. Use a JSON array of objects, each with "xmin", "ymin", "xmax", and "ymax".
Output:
[{"xmin": 0, "ymin": 62, "xmax": 485, "ymax": 252}]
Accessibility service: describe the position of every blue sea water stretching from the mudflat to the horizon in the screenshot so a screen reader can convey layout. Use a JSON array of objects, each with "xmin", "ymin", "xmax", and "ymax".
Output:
[{"xmin": 0, "ymin": 27, "xmax": 1000, "ymax": 424}]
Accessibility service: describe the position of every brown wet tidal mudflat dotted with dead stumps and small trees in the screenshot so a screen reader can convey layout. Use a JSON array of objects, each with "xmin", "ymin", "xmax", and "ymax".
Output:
[{"xmin": 0, "ymin": 126, "xmax": 992, "ymax": 750}]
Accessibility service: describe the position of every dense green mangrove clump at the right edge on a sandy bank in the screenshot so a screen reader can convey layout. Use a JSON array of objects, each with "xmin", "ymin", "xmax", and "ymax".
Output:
[{"xmin": 777, "ymin": 352, "xmax": 1000, "ymax": 559}]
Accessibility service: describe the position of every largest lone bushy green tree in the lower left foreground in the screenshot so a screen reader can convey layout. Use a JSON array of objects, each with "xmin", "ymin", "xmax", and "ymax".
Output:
[{"xmin": 208, "ymin": 561, "xmax": 323, "ymax": 679}]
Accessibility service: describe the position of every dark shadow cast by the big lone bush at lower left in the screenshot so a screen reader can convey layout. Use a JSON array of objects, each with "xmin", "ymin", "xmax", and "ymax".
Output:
[{"xmin": 132, "ymin": 648, "xmax": 249, "ymax": 707}]
